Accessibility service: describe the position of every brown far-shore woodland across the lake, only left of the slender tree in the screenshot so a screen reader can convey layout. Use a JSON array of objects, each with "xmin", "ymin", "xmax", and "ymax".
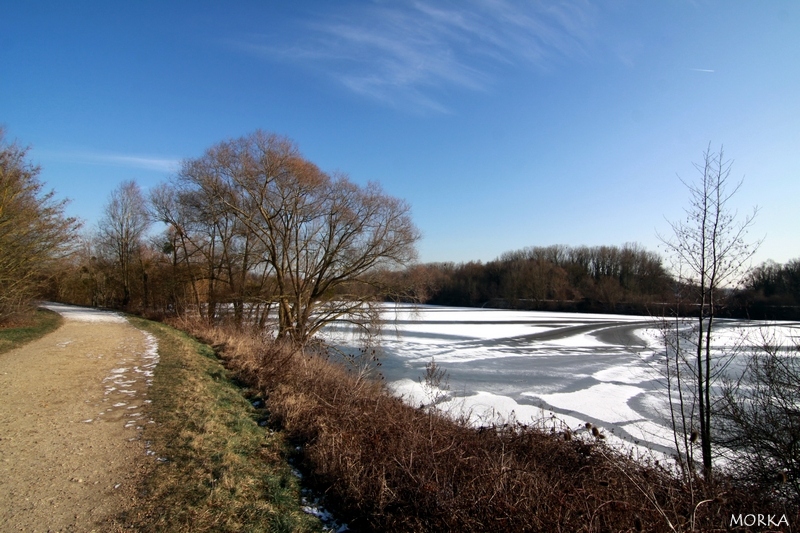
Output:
[{"xmin": 400, "ymin": 243, "xmax": 672, "ymax": 309}]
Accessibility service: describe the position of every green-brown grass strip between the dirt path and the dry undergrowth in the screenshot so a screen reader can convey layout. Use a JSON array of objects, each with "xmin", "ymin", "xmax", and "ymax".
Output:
[{"xmin": 121, "ymin": 318, "xmax": 322, "ymax": 532}]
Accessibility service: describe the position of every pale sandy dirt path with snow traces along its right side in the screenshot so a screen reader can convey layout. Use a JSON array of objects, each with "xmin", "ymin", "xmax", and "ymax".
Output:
[{"xmin": 0, "ymin": 305, "xmax": 157, "ymax": 532}]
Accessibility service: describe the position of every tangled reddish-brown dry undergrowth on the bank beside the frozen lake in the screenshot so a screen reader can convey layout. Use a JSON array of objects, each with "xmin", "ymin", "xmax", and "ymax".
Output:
[{"xmin": 170, "ymin": 316, "xmax": 797, "ymax": 532}]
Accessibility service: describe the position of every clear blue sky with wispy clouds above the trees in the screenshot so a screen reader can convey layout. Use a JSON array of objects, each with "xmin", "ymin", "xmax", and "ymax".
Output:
[{"xmin": 0, "ymin": 0, "xmax": 800, "ymax": 262}]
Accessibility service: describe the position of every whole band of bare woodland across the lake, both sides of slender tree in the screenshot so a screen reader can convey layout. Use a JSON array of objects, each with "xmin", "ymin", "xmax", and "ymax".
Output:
[{"xmin": 386, "ymin": 244, "xmax": 800, "ymax": 319}]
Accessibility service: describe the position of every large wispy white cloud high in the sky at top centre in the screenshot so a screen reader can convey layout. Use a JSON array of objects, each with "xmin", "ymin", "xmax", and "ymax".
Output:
[{"xmin": 232, "ymin": 0, "xmax": 594, "ymax": 112}]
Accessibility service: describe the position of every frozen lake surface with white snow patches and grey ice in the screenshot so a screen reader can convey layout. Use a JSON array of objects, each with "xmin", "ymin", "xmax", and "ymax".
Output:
[{"xmin": 331, "ymin": 305, "xmax": 800, "ymax": 453}]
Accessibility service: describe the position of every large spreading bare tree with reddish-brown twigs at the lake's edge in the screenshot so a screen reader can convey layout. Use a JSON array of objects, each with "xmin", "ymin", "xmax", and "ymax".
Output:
[{"xmin": 166, "ymin": 131, "xmax": 419, "ymax": 344}]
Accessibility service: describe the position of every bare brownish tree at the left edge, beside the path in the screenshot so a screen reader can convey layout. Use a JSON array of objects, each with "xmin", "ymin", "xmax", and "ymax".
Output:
[{"xmin": 0, "ymin": 128, "xmax": 79, "ymax": 322}]
